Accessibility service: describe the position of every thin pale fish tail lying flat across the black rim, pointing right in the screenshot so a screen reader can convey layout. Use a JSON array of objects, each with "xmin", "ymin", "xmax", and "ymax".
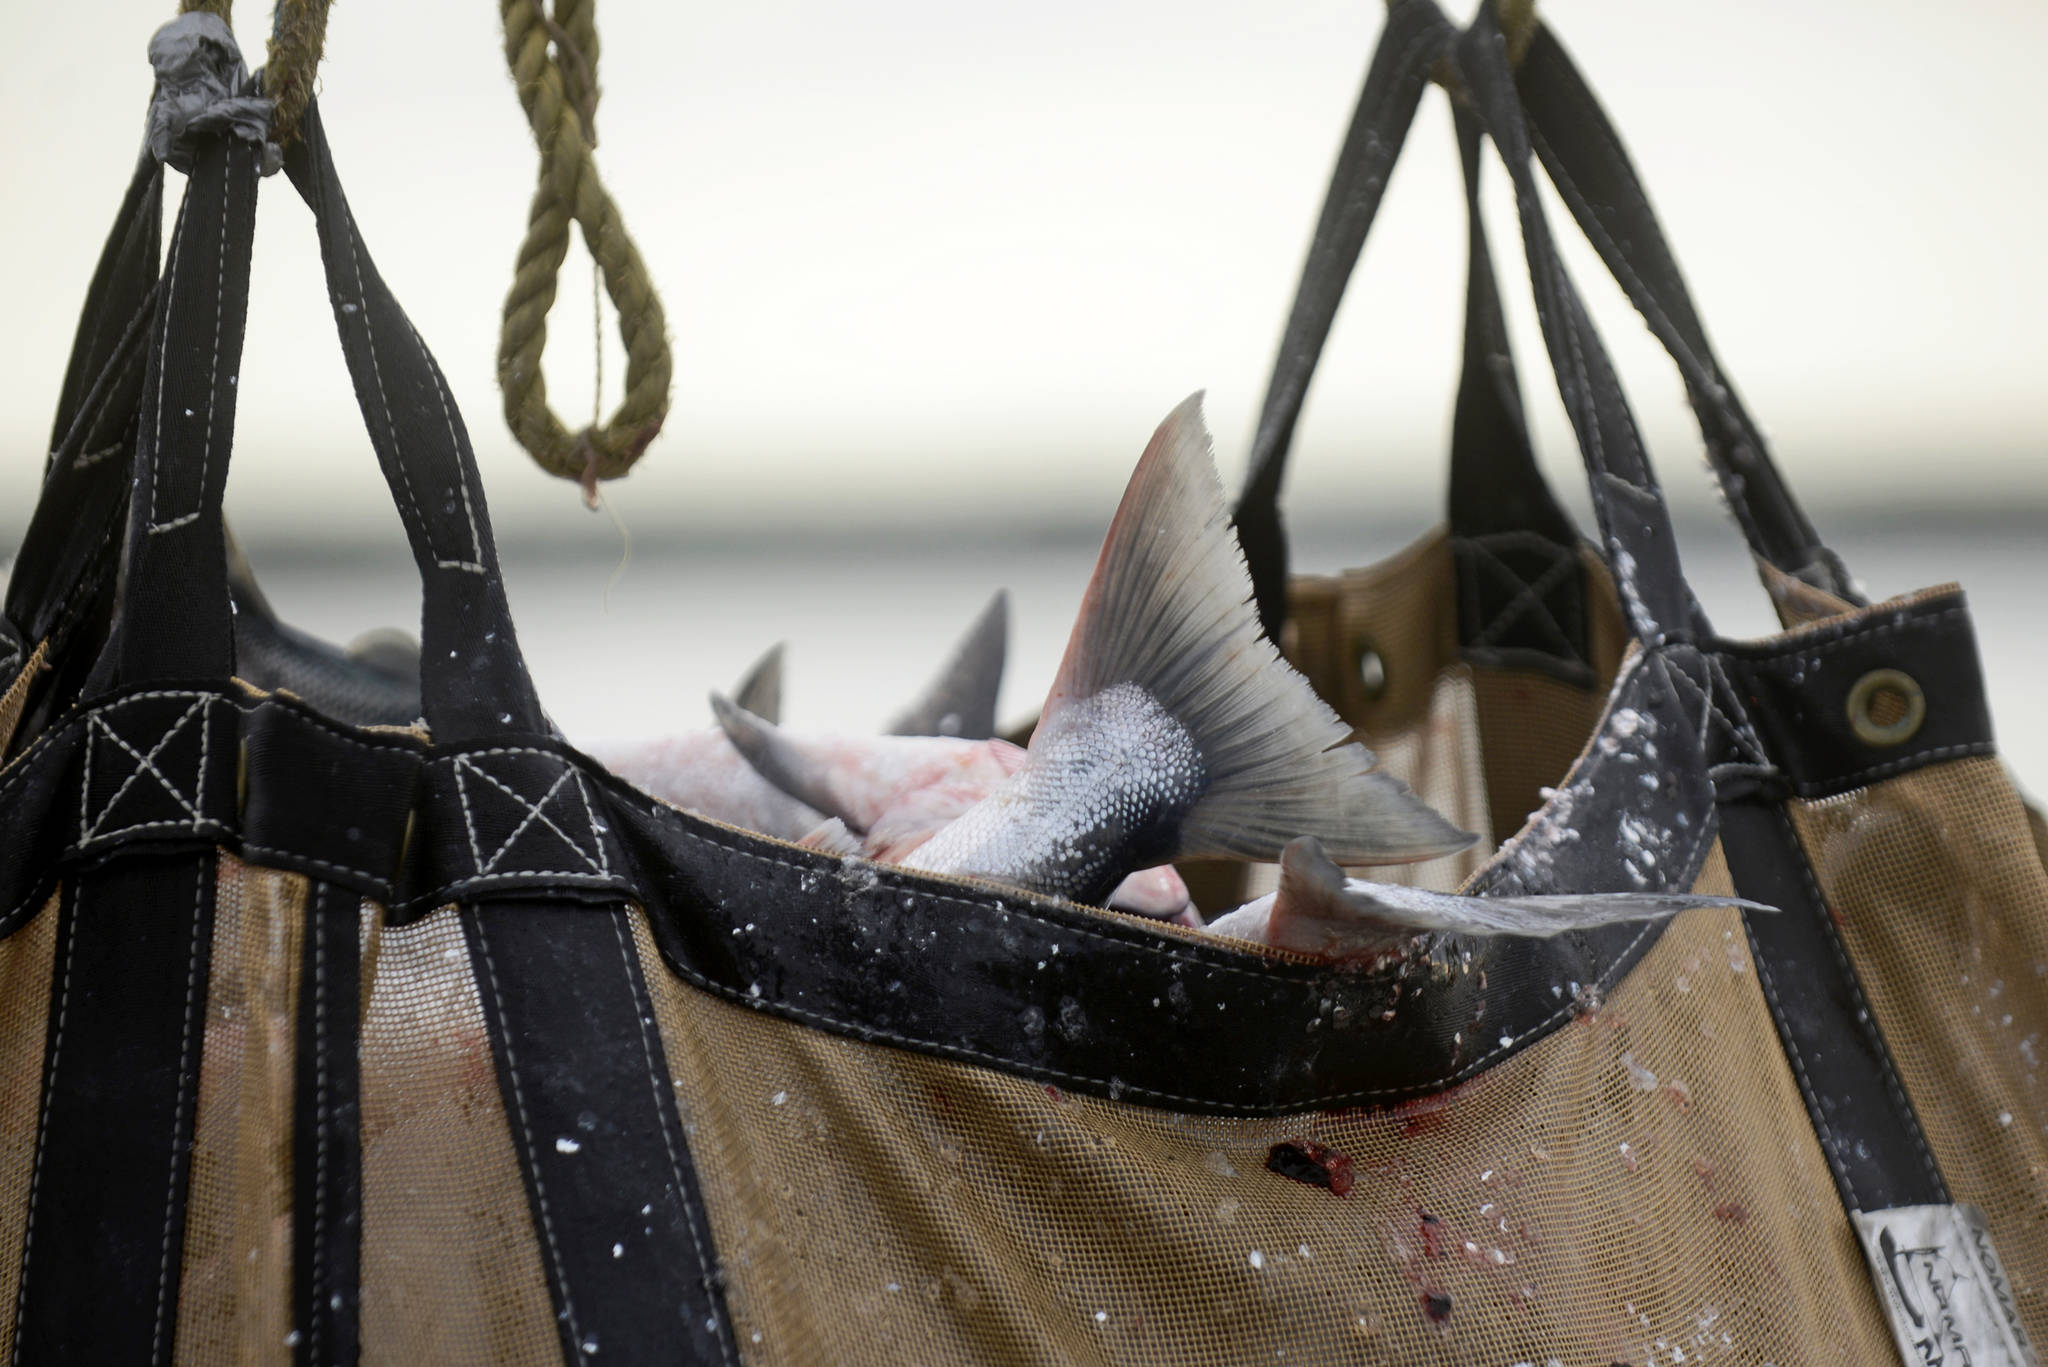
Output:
[{"xmin": 1268, "ymin": 836, "xmax": 1776, "ymax": 951}]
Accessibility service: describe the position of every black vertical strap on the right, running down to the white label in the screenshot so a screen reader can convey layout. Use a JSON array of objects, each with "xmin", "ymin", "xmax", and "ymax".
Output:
[{"xmin": 1720, "ymin": 797, "xmax": 1950, "ymax": 1211}]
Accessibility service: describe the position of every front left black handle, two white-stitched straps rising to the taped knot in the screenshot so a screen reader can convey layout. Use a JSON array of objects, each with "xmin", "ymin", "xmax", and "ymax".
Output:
[{"xmin": 94, "ymin": 107, "xmax": 549, "ymax": 742}]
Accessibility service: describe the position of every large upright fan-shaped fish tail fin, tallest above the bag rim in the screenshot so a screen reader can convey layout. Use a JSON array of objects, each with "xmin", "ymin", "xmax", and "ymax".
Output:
[{"xmin": 1038, "ymin": 393, "xmax": 1475, "ymax": 865}]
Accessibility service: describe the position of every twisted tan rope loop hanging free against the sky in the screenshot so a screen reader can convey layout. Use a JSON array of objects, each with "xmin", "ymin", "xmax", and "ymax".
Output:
[{"xmin": 498, "ymin": 0, "xmax": 672, "ymax": 491}]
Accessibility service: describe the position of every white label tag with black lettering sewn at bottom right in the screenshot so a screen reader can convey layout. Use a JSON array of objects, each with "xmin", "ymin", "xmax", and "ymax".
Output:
[{"xmin": 1849, "ymin": 1205, "xmax": 2040, "ymax": 1367}]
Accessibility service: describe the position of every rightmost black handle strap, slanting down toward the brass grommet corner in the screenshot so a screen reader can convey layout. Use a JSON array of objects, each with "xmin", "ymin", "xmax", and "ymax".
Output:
[{"xmin": 1516, "ymin": 25, "xmax": 1862, "ymax": 603}]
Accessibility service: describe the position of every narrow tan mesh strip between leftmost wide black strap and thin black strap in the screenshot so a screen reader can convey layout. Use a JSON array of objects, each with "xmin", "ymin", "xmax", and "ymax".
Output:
[{"xmin": 176, "ymin": 855, "xmax": 305, "ymax": 1363}]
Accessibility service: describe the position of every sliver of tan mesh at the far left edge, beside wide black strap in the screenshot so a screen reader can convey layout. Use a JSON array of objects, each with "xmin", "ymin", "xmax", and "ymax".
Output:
[{"xmin": 0, "ymin": 894, "xmax": 57, "ymax": 1361}]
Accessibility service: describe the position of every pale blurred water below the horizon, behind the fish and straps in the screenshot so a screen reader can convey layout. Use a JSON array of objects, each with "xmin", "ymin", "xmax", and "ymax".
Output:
[{"xmin": 216, "ymin": 508, "xmax": 2048, "ymax": 791}]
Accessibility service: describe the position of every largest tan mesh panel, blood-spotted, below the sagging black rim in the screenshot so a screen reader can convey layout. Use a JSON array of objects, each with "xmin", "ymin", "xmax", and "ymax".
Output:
[{"xmin": 637, "ymin": 851, "xmax": 1892, "ymax": 1367}]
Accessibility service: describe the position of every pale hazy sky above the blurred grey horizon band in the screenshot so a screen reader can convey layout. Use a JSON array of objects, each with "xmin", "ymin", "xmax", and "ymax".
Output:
[{"xmin": 0, "ymin": 0, "xmax": 2048, "ymax": 545}]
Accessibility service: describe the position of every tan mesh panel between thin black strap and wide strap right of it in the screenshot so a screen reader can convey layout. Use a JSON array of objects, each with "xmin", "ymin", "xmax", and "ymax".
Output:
[{"xmin": 362, "ymin": 906, "xmax": 561, "ymax": 1367}]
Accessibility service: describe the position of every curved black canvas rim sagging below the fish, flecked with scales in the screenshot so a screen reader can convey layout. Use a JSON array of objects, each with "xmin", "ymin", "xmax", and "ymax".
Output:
[{"xmin": 618, "ymin": 654, "xmax": 1716, "ymax": 1115}]
